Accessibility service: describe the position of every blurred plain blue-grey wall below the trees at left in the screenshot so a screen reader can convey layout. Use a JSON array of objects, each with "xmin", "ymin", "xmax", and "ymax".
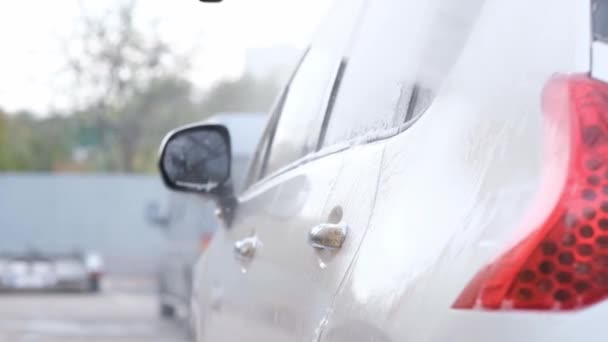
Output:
[{"xmin": 0, "ymin": 173, "xmax": 168, "ymax": 273}]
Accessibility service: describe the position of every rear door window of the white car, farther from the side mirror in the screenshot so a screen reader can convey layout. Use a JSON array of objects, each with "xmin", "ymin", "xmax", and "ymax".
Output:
[{"xmin": 323, "ymin": 0, "xmax": 482, "ymax": 146}]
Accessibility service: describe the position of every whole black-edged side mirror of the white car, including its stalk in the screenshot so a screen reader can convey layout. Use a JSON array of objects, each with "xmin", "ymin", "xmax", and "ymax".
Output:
[{"xmin": 158, "ymin": 124, "xmax": 236, "ymax": 221}]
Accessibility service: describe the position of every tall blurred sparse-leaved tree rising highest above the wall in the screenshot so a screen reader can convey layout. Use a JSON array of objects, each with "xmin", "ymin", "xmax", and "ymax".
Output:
[{"xmin": 68, "ymin": 1, "xmax": 189, "ymax": 172}]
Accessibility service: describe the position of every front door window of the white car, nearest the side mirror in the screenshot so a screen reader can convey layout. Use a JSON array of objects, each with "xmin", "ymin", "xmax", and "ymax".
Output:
[{"xmin": 248, "ymin": 0, "xmax": 365, "ymax": 179}]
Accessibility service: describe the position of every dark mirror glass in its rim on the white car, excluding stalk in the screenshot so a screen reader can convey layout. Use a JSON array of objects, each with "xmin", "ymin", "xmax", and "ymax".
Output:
[{"xmin": 160, "ymin": 125, "xmax": 230, "ymax": 192}]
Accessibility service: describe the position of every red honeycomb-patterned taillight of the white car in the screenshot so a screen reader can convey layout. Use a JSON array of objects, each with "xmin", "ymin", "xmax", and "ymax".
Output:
[{"xmin": 453, "ymin": 75, "xmax": 608, "ymax": 310}]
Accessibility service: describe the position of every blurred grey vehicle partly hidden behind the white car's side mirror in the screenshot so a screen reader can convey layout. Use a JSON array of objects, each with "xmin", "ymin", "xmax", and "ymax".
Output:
[{"xmin": 146, "ymin": 112, "xmax": 267, "ymax": 318}]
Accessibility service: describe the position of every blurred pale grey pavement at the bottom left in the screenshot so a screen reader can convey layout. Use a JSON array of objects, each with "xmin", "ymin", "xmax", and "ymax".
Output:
[{"xmin": 0, "ymin": 279, "xmax": 188, "ymax": 342}]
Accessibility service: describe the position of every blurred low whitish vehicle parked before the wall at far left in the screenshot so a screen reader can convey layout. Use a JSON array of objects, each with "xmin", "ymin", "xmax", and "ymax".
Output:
[{"xmin": 0, "ymin": 249, "xmax": 103, "ymax": 292}]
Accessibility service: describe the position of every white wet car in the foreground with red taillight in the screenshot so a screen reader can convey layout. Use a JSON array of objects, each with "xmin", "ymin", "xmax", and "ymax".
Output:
[{"xmin": 160, "ymin": 0, "xmax": 608, "ymax": 342}]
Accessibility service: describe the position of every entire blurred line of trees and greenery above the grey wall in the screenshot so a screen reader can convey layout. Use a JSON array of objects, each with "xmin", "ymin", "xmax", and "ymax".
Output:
[{"xmin": 0, "ymin": 1, "xmax": 278, "ymax": 172}]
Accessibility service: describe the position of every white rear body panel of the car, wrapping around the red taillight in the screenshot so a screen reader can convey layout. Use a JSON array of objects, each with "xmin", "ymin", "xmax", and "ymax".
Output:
[{"xmin": 321, "ymin": 1, "xmax": 592, "ymax": 341}]
